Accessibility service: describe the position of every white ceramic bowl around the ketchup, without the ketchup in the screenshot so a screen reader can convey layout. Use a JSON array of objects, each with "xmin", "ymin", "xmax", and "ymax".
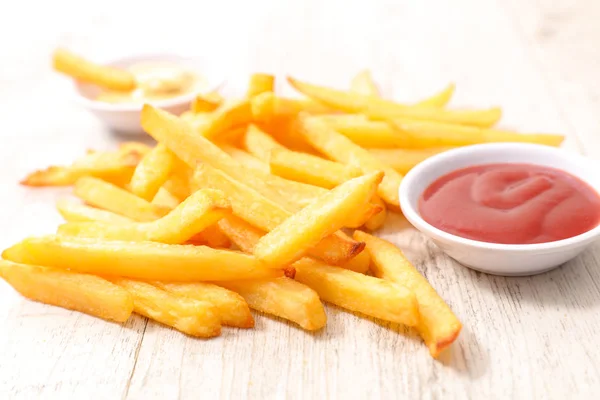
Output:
[{"xmin": 400, "ymin": 143, "xmax": 600, "ymax": 276}]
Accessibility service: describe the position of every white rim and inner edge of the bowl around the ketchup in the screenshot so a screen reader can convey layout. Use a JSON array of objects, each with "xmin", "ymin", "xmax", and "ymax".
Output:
[{"xmin": 399, "ymin": 143, "xmax": 600, "ymax": 252}]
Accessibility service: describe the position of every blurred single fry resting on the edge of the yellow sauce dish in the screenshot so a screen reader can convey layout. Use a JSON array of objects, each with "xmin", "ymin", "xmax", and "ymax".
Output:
[{"xmin": 52, "ymin": 49, "xmax": 136, "ymax": 91}]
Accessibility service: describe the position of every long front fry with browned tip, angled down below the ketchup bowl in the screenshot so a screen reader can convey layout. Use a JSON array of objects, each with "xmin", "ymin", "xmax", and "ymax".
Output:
[{"xmin": 354, "ymin": 231, "xmax": 462, "ymax": 357}]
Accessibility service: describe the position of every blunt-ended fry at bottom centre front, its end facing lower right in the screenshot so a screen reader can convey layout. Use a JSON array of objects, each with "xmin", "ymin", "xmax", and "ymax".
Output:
[{"xmin": 217, "ymin": 277, "xmax": 327, "ymax": 331}]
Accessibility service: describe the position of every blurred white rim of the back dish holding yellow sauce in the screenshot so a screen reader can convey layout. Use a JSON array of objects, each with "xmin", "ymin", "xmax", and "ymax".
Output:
[{"xmin": 73, "ymin": 53, "xmax": 225, "ymax": 112}]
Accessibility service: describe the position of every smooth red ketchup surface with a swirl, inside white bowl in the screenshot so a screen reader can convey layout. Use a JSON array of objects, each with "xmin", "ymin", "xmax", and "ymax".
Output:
[{"xmin": 419, "ymin": 164, "xmax": 600, "ymax": 244}]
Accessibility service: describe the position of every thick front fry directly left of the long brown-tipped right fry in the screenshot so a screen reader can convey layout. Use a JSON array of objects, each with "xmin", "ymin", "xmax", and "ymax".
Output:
[{"xmin": 294, "ymin": 258, "xmax": 419, "ymax": 326}]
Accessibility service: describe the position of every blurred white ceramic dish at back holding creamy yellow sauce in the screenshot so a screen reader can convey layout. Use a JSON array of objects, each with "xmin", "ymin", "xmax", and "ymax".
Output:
[{"xmin": 74, "ymin": 54, "xmax": 224, "ymax": 135}]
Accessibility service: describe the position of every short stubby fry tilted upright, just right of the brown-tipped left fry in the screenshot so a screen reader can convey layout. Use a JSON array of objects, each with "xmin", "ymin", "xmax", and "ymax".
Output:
[{"xmin": 129, "ymin": 143, "xmax": 177, "ymax": 201}]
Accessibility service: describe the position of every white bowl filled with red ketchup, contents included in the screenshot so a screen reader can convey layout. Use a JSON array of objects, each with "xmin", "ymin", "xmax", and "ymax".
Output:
[{"xmin": 400, "ymin": 143, "xmax": 600, "ymax": 276}]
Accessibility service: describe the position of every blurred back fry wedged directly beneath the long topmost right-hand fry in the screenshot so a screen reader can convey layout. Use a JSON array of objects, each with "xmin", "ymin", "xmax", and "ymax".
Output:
[{"xmin": 314, "ymin": 114, "xmax": 410, "ymax": 148}]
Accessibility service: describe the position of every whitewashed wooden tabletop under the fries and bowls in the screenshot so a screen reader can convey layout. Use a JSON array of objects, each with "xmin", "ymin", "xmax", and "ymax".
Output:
[{"xmin": 0, "ymin": 0, "xmax": 600, "ymax": 399}]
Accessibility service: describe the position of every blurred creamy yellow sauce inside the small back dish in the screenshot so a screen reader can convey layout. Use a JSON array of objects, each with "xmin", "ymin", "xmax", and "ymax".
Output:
[{"xmin": 96, "ymin": 62, "xmax": 206, "ymax": 103}]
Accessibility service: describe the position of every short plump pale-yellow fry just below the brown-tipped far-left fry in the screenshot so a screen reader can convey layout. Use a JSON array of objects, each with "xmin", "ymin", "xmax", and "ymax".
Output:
[{"xmin": 73, "ymin": 177, "xmax": 170, "ymax": 221}]
